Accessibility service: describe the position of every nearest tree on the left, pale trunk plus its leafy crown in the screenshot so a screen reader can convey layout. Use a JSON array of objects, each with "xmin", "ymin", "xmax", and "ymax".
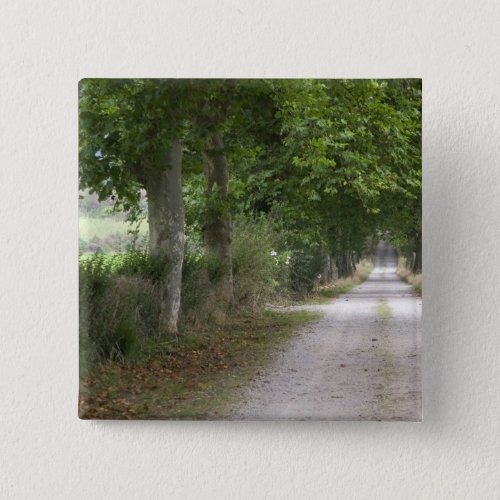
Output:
[{"xmin": 79, "ymin": 79, "xmax": 186, "ymax": 333}]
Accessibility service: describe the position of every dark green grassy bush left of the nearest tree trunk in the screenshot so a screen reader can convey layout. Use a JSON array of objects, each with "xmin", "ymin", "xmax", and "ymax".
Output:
[{"xmin": 80, "ymin": 252, "xmax": 164, "ymax": 360}]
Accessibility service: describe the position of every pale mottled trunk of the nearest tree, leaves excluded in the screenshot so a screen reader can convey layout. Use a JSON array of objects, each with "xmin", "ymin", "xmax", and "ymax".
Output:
[{"xmin": 146, "ymin": 141, "xmax": 185, "ymax": 334}]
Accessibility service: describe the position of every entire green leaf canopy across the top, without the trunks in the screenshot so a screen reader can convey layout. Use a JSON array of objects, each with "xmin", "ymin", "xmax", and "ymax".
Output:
[{"xmin": 80, "ymin": 79, "xmax": 421, "ymax": 254}]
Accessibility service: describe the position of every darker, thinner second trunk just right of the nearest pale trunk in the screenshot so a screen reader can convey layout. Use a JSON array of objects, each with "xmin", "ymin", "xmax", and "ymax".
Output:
[{"xmin": 204, "ymin": 133, "xmax": 234, "ymax": 302}]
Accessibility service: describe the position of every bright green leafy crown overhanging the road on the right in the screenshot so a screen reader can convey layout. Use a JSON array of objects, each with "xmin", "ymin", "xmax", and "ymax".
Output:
[{"xmin": 227, "ymin": 80, "xmax": 421, "ymax": 275}]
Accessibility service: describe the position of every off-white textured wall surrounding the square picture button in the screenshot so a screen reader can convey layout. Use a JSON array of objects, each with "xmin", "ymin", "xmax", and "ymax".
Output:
[{"xmin": 0, "ymin": 0, "xmax": 500, "ymax": 499}]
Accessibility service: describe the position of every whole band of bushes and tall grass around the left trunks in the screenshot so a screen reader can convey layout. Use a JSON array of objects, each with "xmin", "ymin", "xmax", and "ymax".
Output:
[{"xmin": 80, "ymin": 215, "xmax": 326, "ymax": 361}]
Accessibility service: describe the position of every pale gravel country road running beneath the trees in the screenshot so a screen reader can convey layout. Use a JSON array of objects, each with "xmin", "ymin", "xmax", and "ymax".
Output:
[{"xmin": 231, "ymin": 242, "xmax": 422, "ymax": 421}]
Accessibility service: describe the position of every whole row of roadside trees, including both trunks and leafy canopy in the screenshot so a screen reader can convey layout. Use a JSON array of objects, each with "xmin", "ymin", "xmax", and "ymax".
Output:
[{"xmin": 80, "ymin": 79, "xmax": 421, "ymax": 333}]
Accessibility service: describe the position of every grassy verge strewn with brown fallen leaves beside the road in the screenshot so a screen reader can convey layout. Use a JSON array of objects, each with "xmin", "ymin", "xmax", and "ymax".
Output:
[{"xmin": 79, "ymin": 311, "xmax": 321, "ymax": 419}]
